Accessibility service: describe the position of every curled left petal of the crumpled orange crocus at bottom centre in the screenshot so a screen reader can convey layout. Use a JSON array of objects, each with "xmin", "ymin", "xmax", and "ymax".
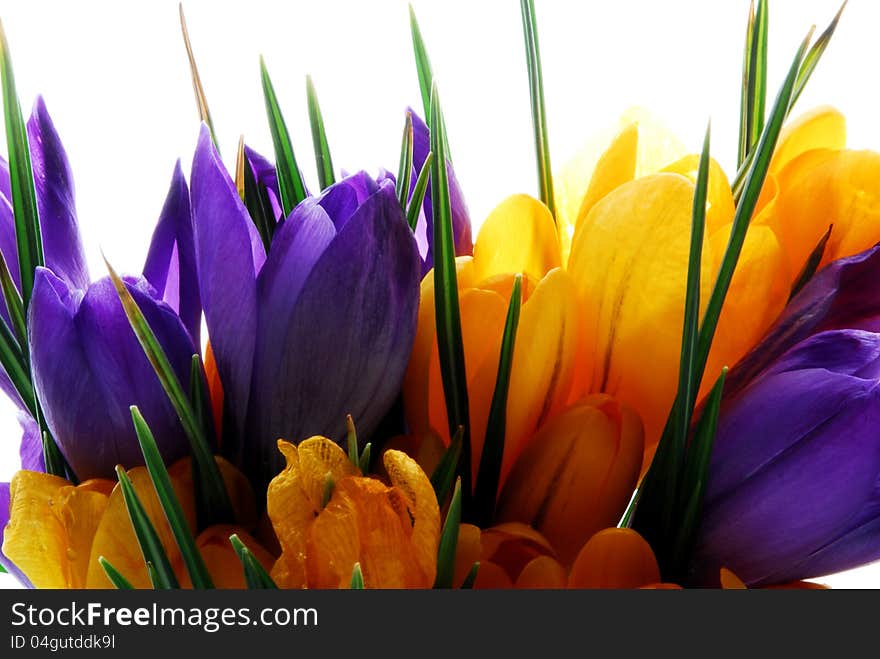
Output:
[{"xmin": 266, "ymin": 437, "xmax": 360, "ymax": 588}]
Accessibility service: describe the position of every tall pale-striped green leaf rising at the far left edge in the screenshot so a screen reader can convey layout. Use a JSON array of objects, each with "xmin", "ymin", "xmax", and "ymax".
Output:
[{"xmin": 0, "ymin": 23, "xmax": 44, "ymax": 314}]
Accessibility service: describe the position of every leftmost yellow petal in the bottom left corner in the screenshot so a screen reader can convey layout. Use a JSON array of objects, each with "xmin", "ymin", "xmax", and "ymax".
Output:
[{"xmin": 3, "ymin": 471, "xmax": 113, "ymax": 588}]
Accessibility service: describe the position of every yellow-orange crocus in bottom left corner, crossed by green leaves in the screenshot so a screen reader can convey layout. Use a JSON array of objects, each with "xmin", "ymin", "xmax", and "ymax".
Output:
[{"xmin": 3, "ymin": 458, "xmax": 266, "ymax": 588}]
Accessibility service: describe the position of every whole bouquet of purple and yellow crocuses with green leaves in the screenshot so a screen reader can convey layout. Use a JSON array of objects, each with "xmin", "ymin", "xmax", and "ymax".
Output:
[{"xmin": 0, "ymin": 0, "xmax": 880, "ymax": 589}]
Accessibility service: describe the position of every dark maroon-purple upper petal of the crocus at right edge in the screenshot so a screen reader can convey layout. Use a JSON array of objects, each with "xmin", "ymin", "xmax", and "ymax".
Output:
[{"xmin": 725, "ymin": 247, "xmax": 880, "ymax": 395}]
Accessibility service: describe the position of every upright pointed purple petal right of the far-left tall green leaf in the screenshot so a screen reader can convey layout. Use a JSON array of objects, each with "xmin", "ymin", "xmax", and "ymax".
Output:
[{"xmin": 27, "ymin": 96, "xmax": 89, "ymax": 289}]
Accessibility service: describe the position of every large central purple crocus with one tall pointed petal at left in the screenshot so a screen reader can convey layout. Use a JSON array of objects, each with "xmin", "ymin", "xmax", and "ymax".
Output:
[{"xmin": 191, "ymin": 127, "xmax": 420, "ymax": 482}]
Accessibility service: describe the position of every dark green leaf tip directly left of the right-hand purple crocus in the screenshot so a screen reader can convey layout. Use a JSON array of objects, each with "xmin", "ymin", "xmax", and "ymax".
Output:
[{"xmin": 673, "ymin": 367, "xmax": 727, "ymax": 575}]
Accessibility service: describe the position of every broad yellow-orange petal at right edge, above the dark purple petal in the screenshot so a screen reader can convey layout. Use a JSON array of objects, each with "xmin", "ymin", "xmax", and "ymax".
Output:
[{"xmin": 762, "ymin": 150, "xmax": 880, "ymax": 280}]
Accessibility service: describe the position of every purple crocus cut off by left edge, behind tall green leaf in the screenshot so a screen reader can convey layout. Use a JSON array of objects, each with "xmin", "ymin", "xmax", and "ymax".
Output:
[{"xmin": 0, "ymin": 97, "xmax": 89, "ymax": 409}]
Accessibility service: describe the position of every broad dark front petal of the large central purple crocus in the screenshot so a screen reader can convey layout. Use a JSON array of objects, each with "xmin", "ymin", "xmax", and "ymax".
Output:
[{"xmin": 242, "ymin": 183, "xmax": 419, "ymax": 484}]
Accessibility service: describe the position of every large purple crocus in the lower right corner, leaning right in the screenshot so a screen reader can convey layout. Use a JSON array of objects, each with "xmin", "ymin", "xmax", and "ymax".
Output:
[{"xmin": 692, "ymin": 248, "xmax": 880, "ymax": 585}]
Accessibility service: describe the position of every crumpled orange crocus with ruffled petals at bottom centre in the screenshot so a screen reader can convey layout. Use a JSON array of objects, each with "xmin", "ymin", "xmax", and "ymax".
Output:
[{"xmin": 266, "ymin": 437, "xmax": 440, "ymax": 588}]
